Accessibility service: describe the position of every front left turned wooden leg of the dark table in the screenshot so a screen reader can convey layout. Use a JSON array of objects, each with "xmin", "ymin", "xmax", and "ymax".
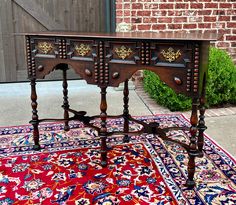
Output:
[{"xmin": 30, "ymin": 79, "xmax": 40, "ymax": 150}]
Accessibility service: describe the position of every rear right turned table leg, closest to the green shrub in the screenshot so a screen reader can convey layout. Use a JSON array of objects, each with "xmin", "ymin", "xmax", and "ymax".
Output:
[{"xmin": 198, "ymin": 76, "xmax": 207, "ymax": 157}]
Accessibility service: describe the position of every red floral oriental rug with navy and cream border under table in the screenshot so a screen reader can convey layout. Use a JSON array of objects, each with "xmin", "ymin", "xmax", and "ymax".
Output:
[{"xmin": 0, "ymin": 115, "xmax": 236, "ymax": 205}]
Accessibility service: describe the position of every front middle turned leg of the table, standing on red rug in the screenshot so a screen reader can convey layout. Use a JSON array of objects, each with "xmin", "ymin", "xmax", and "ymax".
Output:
[{"xmin": 100, "ymin": 87, "xmax": 107, "ymax": 167}]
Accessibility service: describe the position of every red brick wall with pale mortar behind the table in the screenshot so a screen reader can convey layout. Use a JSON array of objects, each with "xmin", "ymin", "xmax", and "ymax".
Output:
[{"xmin": 116, "ymin": 0, "xmax": 236, "ymax": 63}]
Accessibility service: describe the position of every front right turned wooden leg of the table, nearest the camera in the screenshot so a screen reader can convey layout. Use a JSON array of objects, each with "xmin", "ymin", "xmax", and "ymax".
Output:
[{"xmin": 187, "ymin": 98, "xmax": 198, "ymax": 188}]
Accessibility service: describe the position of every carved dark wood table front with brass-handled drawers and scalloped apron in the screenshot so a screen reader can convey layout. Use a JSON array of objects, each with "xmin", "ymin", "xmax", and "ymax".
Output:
[{"xmin": 27, "ymin": 36, "xmax": 199, "ymax": 94}]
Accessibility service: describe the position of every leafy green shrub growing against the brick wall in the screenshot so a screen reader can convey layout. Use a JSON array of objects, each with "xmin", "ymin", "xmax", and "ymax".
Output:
[{"xmin": 144, "ymin": 47, "xmax": 236, "ymax": 111}]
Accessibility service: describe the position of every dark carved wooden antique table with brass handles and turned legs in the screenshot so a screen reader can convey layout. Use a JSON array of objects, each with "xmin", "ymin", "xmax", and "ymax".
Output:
[{"xmin": 25, "ymin": 32, "xmax": 217, "ymax": 187}]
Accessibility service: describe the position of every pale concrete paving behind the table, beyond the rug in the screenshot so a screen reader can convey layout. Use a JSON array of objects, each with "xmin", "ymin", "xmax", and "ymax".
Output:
[{"xmin": 0, "ymin": 80, "xmax": 236, "ymax": 157}]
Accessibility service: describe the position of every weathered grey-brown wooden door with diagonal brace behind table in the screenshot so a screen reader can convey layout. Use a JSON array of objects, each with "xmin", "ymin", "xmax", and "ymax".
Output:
[{"xmin": 0, "ymin": 0, "xmax": 115, "ymax": 82}]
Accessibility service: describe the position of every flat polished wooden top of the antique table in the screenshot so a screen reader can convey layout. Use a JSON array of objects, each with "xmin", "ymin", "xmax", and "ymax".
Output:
[{"xmin": 20, "ymin": 31, "xmax": 219, "ymax": 41}]
